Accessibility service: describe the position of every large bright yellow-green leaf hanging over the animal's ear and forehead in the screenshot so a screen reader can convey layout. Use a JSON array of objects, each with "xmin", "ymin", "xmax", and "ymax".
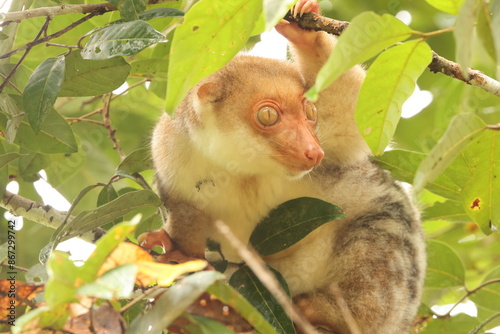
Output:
[{"xmin": 165, "ymin": 0, "xmax": 262, "ymax": 114}]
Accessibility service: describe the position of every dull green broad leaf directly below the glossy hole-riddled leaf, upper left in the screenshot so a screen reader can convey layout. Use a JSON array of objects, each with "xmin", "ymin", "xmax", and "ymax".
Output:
[{"xmin": 59, "ymin": 51, "xmax": 130, "ymax": 96}]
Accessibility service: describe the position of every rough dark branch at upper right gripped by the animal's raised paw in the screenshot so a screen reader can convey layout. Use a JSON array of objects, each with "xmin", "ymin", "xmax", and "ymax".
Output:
[{"xmin": 285, "ymin": 13, "xmax": 500, "ymax": 97}]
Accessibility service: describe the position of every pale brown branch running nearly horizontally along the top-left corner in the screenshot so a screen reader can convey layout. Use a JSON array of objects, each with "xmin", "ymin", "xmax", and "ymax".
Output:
[{"xmin": 0, "ymin": 0, "xmax": 177, "ymax": 25}]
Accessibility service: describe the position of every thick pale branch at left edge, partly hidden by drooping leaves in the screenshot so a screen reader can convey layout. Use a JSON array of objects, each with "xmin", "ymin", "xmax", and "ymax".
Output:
[{"xmin": 0, "ymin": 191, "xmax": 106, "ymax": 243}]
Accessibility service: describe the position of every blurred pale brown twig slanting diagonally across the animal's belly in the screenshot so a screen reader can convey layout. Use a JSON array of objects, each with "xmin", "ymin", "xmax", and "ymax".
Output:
[{"xmin": 215, "ymin": 220, "xmax": 315, "ymax": 334}]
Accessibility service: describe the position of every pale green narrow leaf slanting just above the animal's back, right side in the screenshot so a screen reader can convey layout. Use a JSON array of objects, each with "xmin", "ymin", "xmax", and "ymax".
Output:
[{"xmin": 413, "ymin": 113, "xmax": 486, "ymax": 193}]
